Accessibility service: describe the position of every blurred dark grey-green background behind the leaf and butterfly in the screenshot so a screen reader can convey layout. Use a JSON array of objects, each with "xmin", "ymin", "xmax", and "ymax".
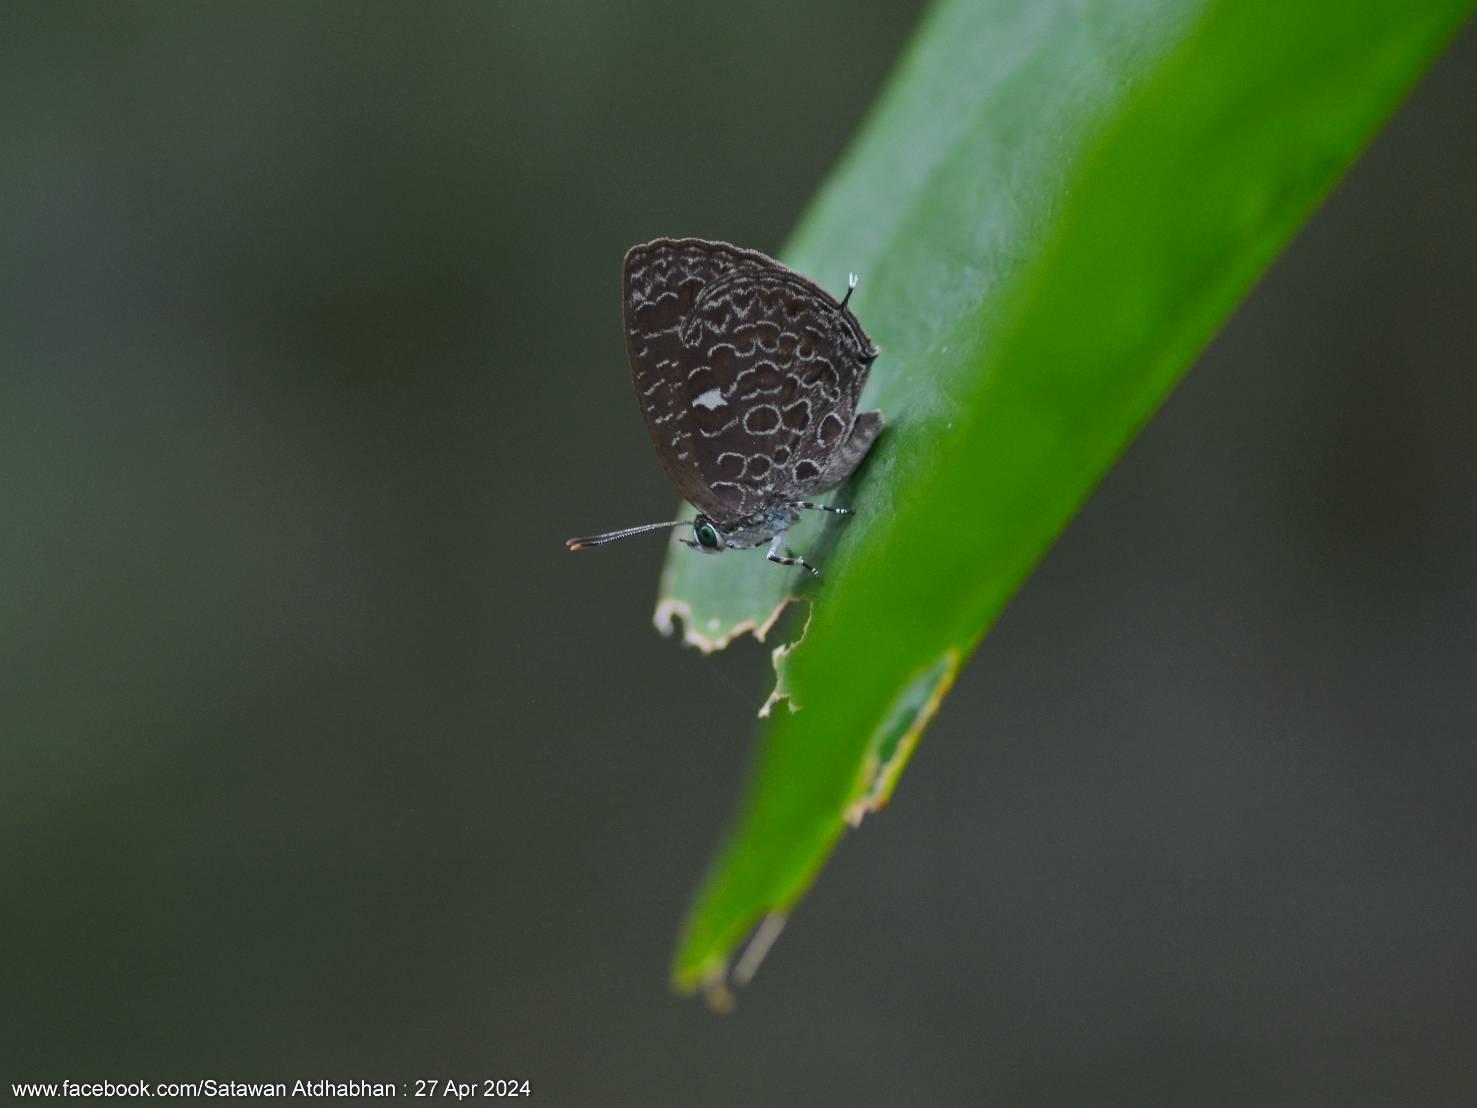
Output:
[{"xmin": 0, "ymin": 0, "xmax": 1477, "ymax": 1105}]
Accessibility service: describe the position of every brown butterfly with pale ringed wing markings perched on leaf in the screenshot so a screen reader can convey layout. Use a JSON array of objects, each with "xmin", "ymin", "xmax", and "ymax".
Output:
[{"xmin": 564, "ymin": 238, "xmax": 883, "ymax": 576}]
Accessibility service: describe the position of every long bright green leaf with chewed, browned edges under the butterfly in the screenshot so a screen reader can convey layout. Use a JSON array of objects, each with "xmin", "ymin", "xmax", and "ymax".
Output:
[{"xmin": 657, "ymin": 0, "xmax": 1473, "ymax": 997}]
